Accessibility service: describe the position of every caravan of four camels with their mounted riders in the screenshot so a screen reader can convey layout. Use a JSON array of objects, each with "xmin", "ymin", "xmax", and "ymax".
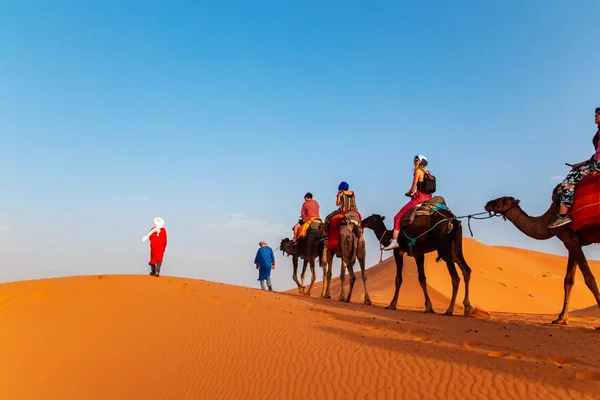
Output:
[{"xmin": 280, "ymin": 107, "xmax": 600, "ymax": 329}]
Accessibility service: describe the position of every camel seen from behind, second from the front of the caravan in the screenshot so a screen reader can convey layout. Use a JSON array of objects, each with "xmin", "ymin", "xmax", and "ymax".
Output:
[{"xmin": 320, "ymin": 211, "xmax": 371, "ymax": 305}]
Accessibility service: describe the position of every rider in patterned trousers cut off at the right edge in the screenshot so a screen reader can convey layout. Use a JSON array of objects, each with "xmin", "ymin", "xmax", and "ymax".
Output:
[{"xmin": 548, "ymin": 107, "xmax": 600, "ymax": 229}]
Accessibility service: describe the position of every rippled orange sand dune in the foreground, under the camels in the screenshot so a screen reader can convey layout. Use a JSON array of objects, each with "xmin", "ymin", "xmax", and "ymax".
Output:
[{"xmin": 0, "ymin": 276, "xmax": 600, "ymax": 400}]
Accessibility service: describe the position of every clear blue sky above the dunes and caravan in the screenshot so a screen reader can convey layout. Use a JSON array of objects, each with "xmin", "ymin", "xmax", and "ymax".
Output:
[{"xmin": 0, "ymin": 0, "xmax": 600, "ymax": 290}]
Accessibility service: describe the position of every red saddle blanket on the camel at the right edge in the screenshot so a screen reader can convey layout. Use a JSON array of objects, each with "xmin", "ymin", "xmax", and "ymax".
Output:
[{"xmin": 570, "ymin": 172, "xmax": 600, "ymax": 231}]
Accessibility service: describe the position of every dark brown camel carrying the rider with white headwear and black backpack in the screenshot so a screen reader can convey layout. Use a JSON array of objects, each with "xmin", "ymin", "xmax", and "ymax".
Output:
[{"xmin": 362, "ymin": 206, "xmax": 473, "ymax": 315}]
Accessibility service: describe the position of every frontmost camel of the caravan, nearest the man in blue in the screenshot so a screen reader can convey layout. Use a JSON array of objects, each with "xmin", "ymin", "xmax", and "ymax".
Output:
[{"xmin": 279, "ymin": 221, "xmax": 327, "ymax": 296}]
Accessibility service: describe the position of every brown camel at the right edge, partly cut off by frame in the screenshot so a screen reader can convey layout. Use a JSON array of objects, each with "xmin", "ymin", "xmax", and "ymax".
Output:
[{"xmin": 485, "ymin": 192, "xmax": 600, "ymax": 329}]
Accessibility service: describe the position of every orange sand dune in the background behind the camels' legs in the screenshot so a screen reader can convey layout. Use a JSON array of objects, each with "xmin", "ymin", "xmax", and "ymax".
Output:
[{"xmin": 288, "ymin": 238, "xmax": 600, "ymax": 314}]
